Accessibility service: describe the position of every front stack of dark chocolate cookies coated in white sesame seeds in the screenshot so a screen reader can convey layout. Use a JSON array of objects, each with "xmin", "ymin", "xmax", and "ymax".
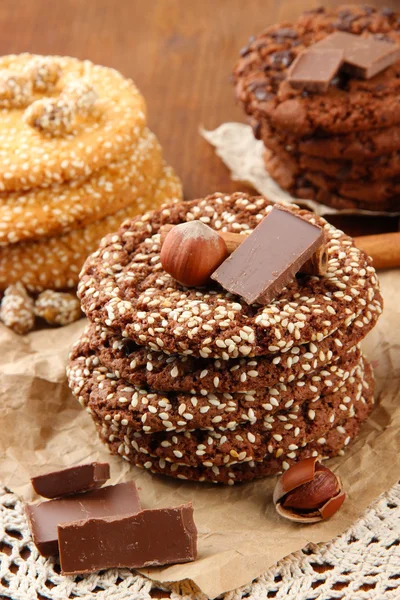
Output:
[{"xmin": 68, "ymin": 193, "xmax": 382, "ymax": 485}]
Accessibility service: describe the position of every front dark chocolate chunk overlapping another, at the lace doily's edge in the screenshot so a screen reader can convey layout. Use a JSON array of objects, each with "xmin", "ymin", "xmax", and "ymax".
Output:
[{"xmin": 58, "ymin": 504, "xmax": 197, "ymax": 575}]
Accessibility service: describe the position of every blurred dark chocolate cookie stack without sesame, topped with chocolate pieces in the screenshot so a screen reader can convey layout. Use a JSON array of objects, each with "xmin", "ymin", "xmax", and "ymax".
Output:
[{"xmin": 234, "ymin": 5, "xmax": 400, "ymax": 212}]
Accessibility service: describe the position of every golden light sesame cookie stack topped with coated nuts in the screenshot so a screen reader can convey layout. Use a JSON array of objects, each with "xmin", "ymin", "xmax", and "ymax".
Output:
[{"xmin": 0, "ymin": 54, "xmax": 181, "ymax": 332}]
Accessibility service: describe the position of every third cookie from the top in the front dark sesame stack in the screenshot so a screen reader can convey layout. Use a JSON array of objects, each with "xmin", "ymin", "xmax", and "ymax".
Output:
[{"xmin": 68, "ymin": 347, "xmax": 363, "ymax": 434}]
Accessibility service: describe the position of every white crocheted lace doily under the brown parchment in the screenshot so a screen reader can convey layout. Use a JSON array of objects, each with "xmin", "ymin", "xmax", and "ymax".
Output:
[{"xmin": 0, "ymin": 484, "xmax": 400, "ymax": 600}]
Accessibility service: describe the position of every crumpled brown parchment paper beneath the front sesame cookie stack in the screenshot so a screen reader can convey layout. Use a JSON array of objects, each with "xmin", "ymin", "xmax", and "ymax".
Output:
[{"xmin": 0, "ymin": 270, "xmax": 400, "ymax": 598}]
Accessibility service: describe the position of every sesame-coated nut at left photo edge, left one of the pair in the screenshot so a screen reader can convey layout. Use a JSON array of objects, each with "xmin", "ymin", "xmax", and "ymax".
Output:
[{"xmin": 0, "ymin": 283, "xmax": 35, "ymax": 335}]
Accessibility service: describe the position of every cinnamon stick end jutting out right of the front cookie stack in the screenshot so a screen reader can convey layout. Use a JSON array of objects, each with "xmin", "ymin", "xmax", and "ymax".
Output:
[{"xmin": 354, "ymin": 232, "xmax": 400, "ymax": 269}]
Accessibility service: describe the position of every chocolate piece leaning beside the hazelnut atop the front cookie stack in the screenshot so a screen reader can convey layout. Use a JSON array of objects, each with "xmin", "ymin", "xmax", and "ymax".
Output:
[{"xmin": 211, "ymin": 205, "xmax": 324, "ymax": 304}]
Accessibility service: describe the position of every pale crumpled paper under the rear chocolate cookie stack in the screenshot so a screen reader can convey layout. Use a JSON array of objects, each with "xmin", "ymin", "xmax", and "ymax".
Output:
[{"xmin": 200, "ymin": 123, "xmax": 400, "ymax": 216}]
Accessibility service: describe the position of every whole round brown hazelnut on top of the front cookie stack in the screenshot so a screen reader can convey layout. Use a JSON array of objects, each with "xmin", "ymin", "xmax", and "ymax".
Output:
[{"xmin": 160, "ymin": 221, "xmax": 228, "ymax": 287}]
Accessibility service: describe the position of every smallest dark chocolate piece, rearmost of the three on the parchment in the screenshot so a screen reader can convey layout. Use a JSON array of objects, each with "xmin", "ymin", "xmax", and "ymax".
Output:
[{"xmin": 31, "ymin": 463, "xmax": 110, "ymax": 498}]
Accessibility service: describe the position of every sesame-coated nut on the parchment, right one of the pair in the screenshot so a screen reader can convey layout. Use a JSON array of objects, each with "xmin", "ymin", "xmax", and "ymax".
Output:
[{"xmin": 35, "ymin": 290, "xmax": 82, "ymax": 325}]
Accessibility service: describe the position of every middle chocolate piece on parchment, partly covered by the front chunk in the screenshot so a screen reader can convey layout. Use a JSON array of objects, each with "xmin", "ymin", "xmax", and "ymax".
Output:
[{"xmin": 26, "ymin": 481, "xmax": 141, "ymax": 556}]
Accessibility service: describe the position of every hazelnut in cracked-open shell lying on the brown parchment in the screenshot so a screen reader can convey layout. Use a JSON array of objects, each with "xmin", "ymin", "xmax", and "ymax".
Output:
[{"xmin": 273, "ymin": 458, "xmax": 346, "ymax": 523}]
